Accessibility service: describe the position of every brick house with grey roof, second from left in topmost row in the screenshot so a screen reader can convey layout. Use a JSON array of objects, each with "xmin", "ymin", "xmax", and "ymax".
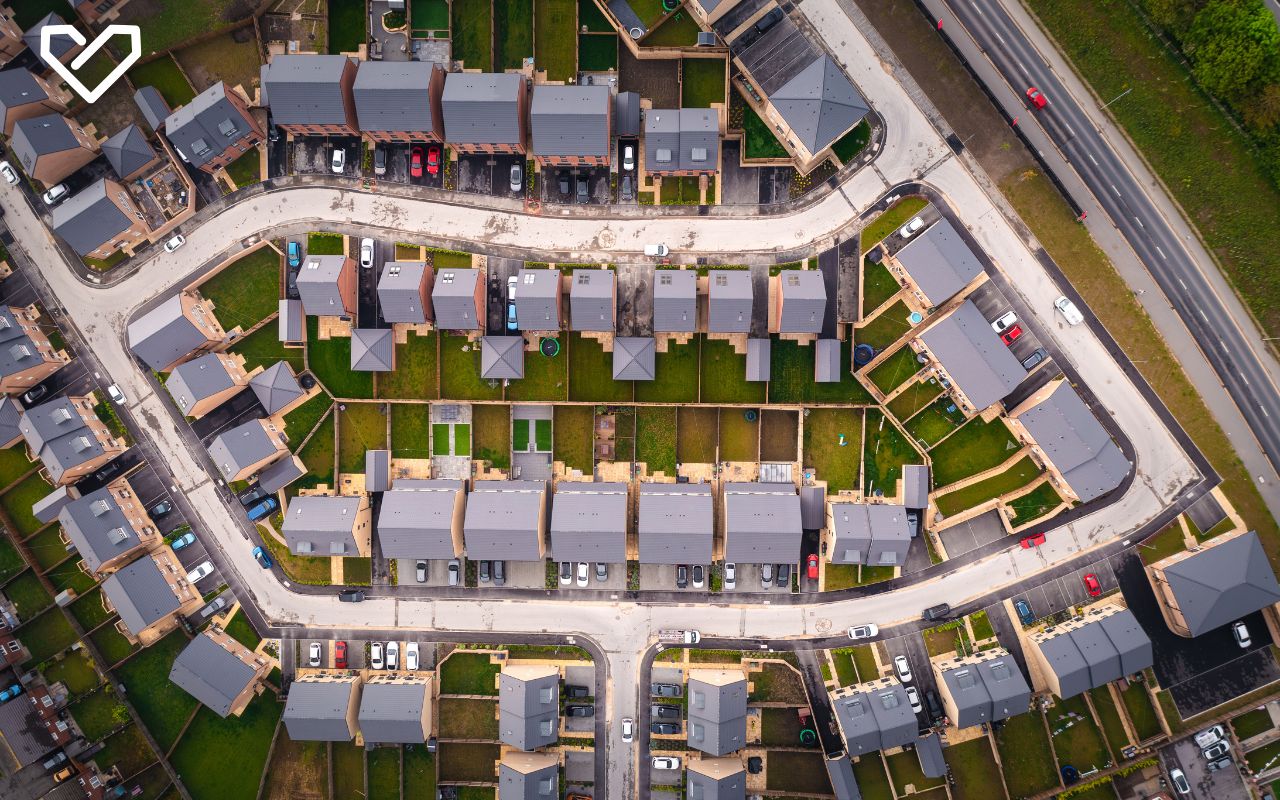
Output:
[{"xmin": 353, "ymin": 61, "xmax": 444, "ymax": 143}]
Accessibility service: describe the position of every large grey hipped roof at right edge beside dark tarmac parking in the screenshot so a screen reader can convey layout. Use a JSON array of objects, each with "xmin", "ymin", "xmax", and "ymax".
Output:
[{"xmin": 1165, "ymin": 531, "xmax": 1280, "ymax": 636}]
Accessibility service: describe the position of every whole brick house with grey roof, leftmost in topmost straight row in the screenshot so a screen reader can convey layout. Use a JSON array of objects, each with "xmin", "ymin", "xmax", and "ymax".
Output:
[{"xmin": 262, "ymin": 55, "xmax": 360, "ymax": 136}]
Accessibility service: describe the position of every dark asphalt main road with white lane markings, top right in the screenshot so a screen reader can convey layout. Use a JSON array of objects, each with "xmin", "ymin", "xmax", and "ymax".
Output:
[{"xmin": 948, "ymin": 0, "xmax": 1280, "ymax": 470}]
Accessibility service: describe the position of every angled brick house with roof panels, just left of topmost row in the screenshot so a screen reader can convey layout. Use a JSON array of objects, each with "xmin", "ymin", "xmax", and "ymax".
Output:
[{"xmin": 164, "ymin": 81, "xmax": 264, "ymax": 174}]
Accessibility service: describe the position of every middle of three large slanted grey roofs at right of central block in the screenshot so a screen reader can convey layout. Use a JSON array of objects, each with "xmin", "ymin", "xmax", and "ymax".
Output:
[{"xmin": 920, "ymin": 300, "xmax": 1027, "ymax": 410}]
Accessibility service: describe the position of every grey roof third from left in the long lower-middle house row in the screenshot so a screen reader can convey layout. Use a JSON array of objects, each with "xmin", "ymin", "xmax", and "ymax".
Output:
[{"xmin": 463, "ymin": 480, "xmax": 547, "ymax": 561}]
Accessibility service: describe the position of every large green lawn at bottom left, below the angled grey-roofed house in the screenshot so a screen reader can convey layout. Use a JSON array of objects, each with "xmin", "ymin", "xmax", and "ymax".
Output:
[{"xmin": 169, "ymin": 691, "xmax": 284, "ymax": 800}]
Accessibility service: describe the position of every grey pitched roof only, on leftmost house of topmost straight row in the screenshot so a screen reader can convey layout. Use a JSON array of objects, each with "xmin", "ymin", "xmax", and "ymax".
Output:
[{"xmin": 262, "ymin": 55, "xmax": 348, "ymax": 125}]
